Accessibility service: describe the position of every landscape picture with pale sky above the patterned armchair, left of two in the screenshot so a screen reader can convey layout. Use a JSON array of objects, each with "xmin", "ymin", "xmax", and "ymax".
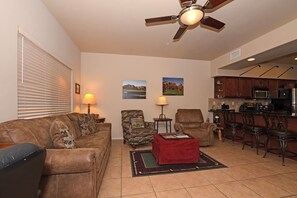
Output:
[{"xmin": 122, "ymin": 80, "xmax": 146, "ymax": 99}]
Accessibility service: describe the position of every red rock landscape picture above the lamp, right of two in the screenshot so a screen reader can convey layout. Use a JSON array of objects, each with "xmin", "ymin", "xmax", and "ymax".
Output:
[{"xmin": 162, "ymin": 77, "xmax": 184, "ymax": 96}]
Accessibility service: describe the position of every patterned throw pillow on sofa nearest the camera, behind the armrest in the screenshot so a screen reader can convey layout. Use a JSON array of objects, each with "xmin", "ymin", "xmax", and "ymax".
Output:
[{"xmin": 50, "ymin": 119, "xmax": 75, "ymax": 149}]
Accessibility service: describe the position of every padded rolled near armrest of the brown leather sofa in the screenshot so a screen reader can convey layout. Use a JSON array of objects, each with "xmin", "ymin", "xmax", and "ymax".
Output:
[{"xmin": 43, "ymin": 148, "xmax": 96, "ymax": 175}]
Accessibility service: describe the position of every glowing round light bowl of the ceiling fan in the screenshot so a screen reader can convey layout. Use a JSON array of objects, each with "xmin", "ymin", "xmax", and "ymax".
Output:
[{"xmin": 179, "ymin": 5, "xmax": 204, "ymax": 26}]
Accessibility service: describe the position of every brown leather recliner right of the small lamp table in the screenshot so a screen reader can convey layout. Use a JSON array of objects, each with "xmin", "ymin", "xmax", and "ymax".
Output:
[{"xmin": 174, "ymin": 109, "xmax": 217, "ymax": 146}]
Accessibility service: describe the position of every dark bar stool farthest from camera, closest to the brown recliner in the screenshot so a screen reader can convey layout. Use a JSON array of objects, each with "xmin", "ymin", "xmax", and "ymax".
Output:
[{"xmin": 223, "ymin": 110, "xmax": 242, "ymax": 143}]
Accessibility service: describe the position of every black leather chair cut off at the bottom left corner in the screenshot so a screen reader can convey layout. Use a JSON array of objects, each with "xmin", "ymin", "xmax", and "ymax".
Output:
[{"xmin": 0, "ymin": 143, "xmax": 46, "ymax": 198}]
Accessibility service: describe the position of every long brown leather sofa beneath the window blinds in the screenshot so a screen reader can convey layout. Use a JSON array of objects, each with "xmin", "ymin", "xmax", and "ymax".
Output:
[{"xmin": 0, "ymin": 113, "xmax": 111, "ymax": 198}]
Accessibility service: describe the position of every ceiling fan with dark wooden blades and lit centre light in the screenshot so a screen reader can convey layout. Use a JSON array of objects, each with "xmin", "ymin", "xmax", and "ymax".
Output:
[{"xmin": 145, "ymin": 0, "xmax": 228, "ymax": 40}]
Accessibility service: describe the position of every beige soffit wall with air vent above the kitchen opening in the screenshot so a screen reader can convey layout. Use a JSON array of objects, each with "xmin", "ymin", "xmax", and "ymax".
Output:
[{"xmin": 211, "ymin": 19, "xmax": 297, "ymax": 79}]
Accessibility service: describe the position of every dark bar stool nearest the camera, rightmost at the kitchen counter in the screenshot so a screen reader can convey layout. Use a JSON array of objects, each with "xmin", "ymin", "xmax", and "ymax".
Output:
[{"xmin": 263, "ymin": 113, "xmax": 297, "ymax": 166}]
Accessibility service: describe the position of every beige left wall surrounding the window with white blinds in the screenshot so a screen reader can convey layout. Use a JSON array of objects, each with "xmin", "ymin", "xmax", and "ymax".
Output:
[{"xmin": 0, "ymin": 0, "xmax": 80, "ymax": 122}]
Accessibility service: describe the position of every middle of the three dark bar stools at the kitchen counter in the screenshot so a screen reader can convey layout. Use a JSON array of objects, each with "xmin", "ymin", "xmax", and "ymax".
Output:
[{"xmin": 241, "ymin": 111, "xmax": 266, "ymax": 155}]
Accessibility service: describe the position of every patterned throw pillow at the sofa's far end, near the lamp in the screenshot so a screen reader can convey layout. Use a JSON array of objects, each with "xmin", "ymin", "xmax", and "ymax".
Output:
[{"xmin": 78, "ymin": 114, "xmax": 98, "ymax": 136}]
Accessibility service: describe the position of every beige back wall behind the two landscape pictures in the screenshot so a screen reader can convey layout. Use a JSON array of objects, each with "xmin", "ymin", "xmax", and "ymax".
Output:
[{"xmin": 81, "ymin": 53, "xmax": 213, "ymax": 138}]
